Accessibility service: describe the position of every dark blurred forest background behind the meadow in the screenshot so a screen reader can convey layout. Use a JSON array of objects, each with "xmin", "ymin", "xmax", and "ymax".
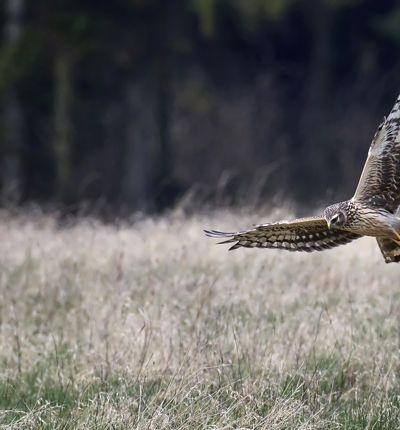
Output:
[{"xmin": 0, "ymin": 0, "xmax": 400, "ymax": 213}]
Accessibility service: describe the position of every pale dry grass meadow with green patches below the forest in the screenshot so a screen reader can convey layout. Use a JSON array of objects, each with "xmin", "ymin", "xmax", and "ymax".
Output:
[{"xmin": 0, "ymin": 206, "xmax": 400, "ymax": 430}]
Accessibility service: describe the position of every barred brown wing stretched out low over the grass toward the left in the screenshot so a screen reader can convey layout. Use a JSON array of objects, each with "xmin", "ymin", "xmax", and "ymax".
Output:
[{"xmin": 205, "ymin": 216, "xmax": 361, "ymax": 252}]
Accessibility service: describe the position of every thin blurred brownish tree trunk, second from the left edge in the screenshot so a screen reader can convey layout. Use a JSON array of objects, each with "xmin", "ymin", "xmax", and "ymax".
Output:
[{"xmin": 53, "ymin": 48, "xmax": 73, "ymax": 202}]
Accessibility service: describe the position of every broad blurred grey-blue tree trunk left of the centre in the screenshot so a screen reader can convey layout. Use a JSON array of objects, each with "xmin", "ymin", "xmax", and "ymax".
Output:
[{"xmin": 125, "ymin": 0, "xmax": 175, "ymax": 211}]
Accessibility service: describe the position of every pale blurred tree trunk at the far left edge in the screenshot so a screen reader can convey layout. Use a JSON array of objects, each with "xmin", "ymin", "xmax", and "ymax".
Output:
[{"xmin": 1, "ymin": 0, "xmax": 25, "ymax": 204}]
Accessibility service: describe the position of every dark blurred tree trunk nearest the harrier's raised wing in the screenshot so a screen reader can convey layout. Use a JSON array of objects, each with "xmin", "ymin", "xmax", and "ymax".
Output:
[{"xmin": 292, "ymin": 0, "xmax": 334, "ymax": 198}]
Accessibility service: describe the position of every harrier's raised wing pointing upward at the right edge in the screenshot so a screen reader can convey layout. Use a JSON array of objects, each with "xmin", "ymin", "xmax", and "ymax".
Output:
[{"xmin": 353, "ymin": 96, "xmax": 400, "ymax": 213}]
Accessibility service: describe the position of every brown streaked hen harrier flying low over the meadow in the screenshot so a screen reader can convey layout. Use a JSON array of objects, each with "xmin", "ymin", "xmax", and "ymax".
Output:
[{"xmin": 205, "ymin": 96, "xmax": 400, "ymax": 263}]
